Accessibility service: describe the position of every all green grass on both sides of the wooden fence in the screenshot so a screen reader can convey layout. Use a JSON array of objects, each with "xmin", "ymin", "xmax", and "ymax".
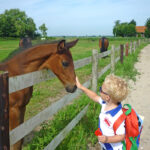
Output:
[{"xmin": 0, "ymin": 38, "xmax": 148, "ymax": 150}]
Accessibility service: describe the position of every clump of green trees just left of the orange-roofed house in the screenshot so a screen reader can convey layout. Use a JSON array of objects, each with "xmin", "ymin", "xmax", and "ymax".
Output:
[{"xmin": 113, "ymin": 20, "xmax": 136, "ymax": 37}]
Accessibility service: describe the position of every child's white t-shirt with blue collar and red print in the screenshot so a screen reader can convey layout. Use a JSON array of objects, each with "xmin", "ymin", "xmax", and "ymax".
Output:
[{"xmin": 99, "ymin": 98, "xmax": 125, "ymax": 150}]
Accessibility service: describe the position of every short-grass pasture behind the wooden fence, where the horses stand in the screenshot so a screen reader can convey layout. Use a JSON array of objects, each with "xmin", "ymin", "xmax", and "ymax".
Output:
[{"xmin": 0, "ymin": 38, "xmax": 138, "ymax": 120}]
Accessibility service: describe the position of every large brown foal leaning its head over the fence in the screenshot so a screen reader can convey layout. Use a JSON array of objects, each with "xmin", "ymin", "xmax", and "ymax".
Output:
[{"xmin": 0, "ymin": 40, "xmax": 78, "ymax": 150}]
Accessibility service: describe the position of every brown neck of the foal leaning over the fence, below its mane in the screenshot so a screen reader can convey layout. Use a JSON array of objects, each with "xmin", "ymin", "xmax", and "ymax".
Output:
[{"xmin": 8, "ymin": 44, "xmax": 56, "ymax": 76}]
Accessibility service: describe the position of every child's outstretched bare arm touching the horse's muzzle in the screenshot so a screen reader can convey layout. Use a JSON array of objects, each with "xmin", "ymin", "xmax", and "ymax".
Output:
[{"xmin": 76, "ymin": 77, "xmax": 100, "ymax": 103}]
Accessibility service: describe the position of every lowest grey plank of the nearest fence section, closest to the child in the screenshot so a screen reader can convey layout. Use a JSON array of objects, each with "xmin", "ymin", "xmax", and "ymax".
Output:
[{"xmin": 44, "ymin": 105, "xmax": 88, "ymax": 150}]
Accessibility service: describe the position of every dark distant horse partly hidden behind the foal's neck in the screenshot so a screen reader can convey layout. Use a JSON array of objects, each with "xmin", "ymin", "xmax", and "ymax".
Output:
[{"xmin": 19, "ymin": 37, "xmax": 32, "ymax": 50}]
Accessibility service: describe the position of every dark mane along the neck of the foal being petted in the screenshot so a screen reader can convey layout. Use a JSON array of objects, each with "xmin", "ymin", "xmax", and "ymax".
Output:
[{"xmin": 1, "ymin": 40, "xmax": 60, "ymax": 63}]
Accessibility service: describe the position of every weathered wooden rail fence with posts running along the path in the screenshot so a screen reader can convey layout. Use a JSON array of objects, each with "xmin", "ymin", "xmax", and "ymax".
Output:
[{"xmin": 0, "ymin": 40, "xmax": 149, "ymax": 150}]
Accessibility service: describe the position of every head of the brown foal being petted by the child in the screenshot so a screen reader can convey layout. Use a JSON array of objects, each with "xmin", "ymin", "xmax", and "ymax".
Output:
[{"xmin": 40, "ymin": 40, "xmax": 78, "ymax": 93}]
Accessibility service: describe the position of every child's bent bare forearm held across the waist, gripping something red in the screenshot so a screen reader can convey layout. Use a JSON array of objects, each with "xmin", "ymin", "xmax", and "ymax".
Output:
[{"xmin": 98, "ymin": 134, "xmax": 125, "ymax": 143}]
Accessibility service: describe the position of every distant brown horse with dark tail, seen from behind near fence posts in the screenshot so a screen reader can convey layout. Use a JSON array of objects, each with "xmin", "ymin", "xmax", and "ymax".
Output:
[{"xmin": 99, "ymin": 37, "xmax": 109, "ymax": 53}]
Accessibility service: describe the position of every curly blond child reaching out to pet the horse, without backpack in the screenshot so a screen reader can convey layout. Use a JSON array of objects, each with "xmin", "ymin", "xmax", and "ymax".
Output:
[{"xmin": 76, "ymin": 75, "xmax": 128, "ymax": 150}]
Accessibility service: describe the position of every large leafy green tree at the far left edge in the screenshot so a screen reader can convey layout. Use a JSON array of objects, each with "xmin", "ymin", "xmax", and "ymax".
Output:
[{"xmin": 0, "ymin": 9, "xmax": 36, "ymax": 37}]
